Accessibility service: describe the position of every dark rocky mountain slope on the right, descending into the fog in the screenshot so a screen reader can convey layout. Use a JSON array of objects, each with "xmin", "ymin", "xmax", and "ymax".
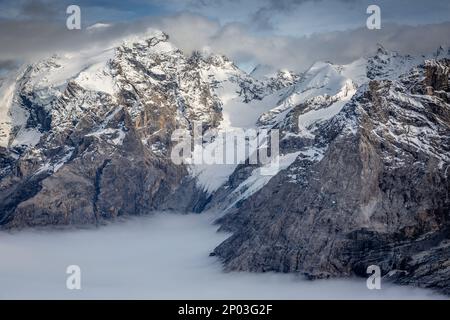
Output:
[{"xmin": 214, "ymin": 60, "xmax": 450, "ymax": 293}]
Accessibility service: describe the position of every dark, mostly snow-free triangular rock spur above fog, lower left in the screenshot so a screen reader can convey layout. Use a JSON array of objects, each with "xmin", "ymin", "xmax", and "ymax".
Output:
[{"xmin": 3, "ymin": 102, "xmax": 169, "ymax": 228}]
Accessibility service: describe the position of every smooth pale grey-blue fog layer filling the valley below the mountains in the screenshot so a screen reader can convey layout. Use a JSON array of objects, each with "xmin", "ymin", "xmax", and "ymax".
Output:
[{"xmin": 0, "ymin": 214, "xmax": 442, "ymax": 299}]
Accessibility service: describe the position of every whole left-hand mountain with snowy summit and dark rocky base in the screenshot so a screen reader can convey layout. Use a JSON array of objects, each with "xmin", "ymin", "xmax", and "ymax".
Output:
[{"xmin": 0, "ymin": 33, "xmax": 221, "ymax": 228}]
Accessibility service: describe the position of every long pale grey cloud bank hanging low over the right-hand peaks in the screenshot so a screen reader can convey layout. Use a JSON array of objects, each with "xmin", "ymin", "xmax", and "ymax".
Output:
[{"xmin": 200, "ymin": 23, "xmax": 450, "ymax": 71}]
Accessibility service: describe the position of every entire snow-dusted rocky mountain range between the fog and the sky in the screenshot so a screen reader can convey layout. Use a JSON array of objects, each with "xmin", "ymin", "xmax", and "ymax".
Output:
[{"xmin": 0, "ymin": 31, "xmax": 450, "ymax": 292}]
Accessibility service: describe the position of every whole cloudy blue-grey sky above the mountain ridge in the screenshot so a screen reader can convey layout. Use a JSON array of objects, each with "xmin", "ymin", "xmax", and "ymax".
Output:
[{"xmin": 0, "ymin": 0, "xmax": 450, "ymax": 71}]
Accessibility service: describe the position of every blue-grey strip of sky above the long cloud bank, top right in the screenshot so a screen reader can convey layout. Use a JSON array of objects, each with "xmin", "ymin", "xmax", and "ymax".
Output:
[{"xmin": 188, "ymin": 0, "xmax": 450, "ymax": 34}]
